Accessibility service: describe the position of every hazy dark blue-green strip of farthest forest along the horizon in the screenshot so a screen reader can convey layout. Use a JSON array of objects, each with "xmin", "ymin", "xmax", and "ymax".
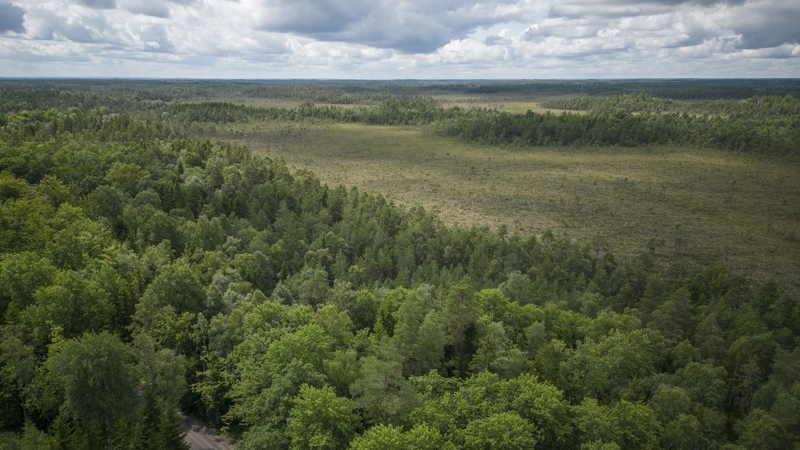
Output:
[{"xmin": 0, "ymin": 79, "xmax": 800, "ymax": 103}]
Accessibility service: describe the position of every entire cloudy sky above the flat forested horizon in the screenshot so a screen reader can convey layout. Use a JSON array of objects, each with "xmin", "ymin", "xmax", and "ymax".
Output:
[{"xmin": 0, "ymin": 0, "xmax": 800, "ymax": 79}]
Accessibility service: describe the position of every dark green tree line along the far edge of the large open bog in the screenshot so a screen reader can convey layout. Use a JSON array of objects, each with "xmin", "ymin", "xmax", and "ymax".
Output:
[{"xmin": 162, "ymin": 97, "xmax": 800, "ymax": 160}]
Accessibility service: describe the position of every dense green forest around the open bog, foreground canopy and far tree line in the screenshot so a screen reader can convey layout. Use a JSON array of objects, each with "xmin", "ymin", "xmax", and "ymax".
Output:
[{"xmin": 0, "ymin": 81, "xmax": 800, "ymax": 450}]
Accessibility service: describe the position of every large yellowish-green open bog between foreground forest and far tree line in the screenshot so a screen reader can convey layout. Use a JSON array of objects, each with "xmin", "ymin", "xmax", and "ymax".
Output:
[{"xmin": 221, "ymin": 124, "xmax": 800, "ymax": 292}]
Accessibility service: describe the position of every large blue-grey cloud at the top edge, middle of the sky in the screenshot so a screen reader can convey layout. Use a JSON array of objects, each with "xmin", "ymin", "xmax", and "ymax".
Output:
[{"xmin": 257, "ymin": 0, "xmax": 516, "ymax": 53}]
